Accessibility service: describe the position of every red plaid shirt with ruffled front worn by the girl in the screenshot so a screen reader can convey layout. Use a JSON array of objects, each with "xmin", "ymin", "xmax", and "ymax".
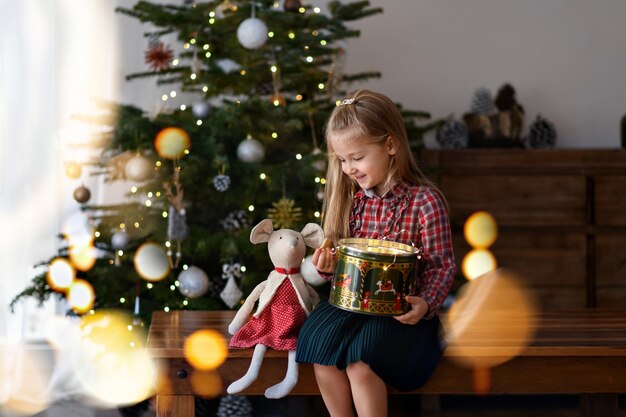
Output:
[{"xmin": 350, "ymin": 183, "xmax": 456, "ymax": 319}]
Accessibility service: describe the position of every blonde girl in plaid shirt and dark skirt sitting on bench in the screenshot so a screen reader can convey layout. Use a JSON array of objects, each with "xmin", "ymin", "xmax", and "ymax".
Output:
[{"xmin": 296, "ymin": 90, "xmax": 456, "ymax": 417}]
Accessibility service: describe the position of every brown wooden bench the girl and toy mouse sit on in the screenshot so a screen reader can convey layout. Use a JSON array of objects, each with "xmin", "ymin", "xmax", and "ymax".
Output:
[{"xmin": 147, "ymin": 309, "xmax": 626, "ymax": 417}]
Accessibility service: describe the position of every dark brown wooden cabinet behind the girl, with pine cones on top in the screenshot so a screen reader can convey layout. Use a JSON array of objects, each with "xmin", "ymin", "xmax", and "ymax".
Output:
[{"xmin": 420, "ymin": 149, "xmax": 626, "ymax": 307}]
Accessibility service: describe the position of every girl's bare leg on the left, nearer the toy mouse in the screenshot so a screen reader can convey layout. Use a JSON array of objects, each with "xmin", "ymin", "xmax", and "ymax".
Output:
[{"xmin": 313, "ymin": 364, "xmax": 354, "ymax": 417}]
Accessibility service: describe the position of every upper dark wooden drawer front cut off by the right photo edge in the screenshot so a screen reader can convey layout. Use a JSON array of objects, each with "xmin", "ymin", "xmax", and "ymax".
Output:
[{"xmin": 594, "ymin": 175, "xmax": 626, "ymax": 226}]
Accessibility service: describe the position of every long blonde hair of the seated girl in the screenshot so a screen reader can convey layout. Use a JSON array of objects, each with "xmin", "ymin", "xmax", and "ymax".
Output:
[{"xmin": 322, "ymin": 90, "xmax": 438, "ymax": 244}]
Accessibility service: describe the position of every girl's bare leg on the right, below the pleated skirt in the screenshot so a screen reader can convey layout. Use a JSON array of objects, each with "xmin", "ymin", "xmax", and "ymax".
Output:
[{"xmin": 346, "ymin": 362, "xmax": 387, "ymax": 417}]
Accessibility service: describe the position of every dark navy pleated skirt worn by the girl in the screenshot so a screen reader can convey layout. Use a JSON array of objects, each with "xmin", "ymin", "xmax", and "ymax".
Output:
[{"xmin": 296, "ymin": 301, "xmax": 442, "ymax": 391}]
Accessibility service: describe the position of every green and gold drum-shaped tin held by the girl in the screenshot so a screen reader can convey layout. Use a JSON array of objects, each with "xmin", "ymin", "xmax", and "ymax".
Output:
[{"xmin": 328, "ymin": 238, "xmax": 421, "ymax": 316}]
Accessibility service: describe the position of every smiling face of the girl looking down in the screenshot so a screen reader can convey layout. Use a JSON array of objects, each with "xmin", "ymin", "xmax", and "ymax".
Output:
[{"xmin": 330, "ymin": 134, "xmax": 396, "ymax": 196}]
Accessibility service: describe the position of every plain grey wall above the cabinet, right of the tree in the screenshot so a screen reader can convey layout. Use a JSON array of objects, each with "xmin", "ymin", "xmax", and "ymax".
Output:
[{"xmin": 347, "ymin": 0, "xmax": 626, "ymax": 148}]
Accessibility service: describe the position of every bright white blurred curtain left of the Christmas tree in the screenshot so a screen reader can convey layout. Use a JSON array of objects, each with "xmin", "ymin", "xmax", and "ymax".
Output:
[{"xmin": 0, "ymin": 0, "xmax": 123, "ymax": 343}]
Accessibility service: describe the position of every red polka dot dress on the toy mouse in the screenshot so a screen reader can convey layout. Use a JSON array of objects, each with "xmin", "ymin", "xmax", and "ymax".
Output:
[{"xmin": 230, "ymin": 278, "xmax": 307, "ymax": 350}]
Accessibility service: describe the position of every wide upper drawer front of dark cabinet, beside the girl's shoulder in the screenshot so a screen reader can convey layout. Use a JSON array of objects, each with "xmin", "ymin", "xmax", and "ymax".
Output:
[{"xmin": 439, "ymin": 174, "xmax": 587, "ymax": 226}]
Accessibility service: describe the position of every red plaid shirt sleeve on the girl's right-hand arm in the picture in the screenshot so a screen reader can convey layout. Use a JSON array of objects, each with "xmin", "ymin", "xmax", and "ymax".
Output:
[{"xmin": 418, "ymin": 190, "xmax": 456, "ymax": 319}]
